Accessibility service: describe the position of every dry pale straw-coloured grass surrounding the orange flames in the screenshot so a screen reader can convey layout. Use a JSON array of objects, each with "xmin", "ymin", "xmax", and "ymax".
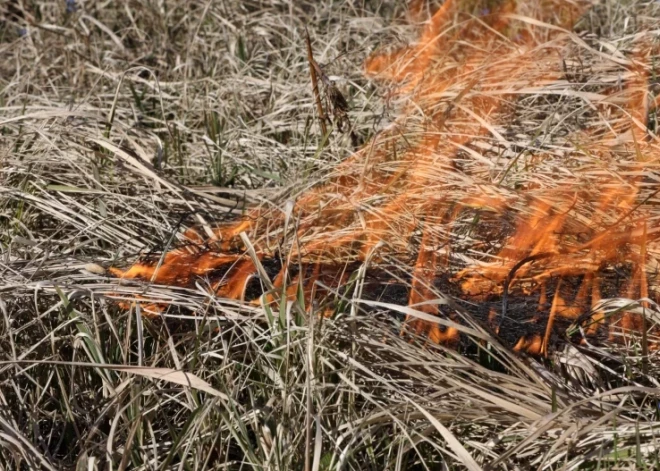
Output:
[{"xmin": 0, "ymin": 0, "xmax": 660, "ymax": 470}]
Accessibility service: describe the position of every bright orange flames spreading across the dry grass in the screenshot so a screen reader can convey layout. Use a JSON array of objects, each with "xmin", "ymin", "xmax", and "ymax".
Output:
[{"xmin": 111, "ymin": 0, "xmax": 660, "ymax": 354}]
